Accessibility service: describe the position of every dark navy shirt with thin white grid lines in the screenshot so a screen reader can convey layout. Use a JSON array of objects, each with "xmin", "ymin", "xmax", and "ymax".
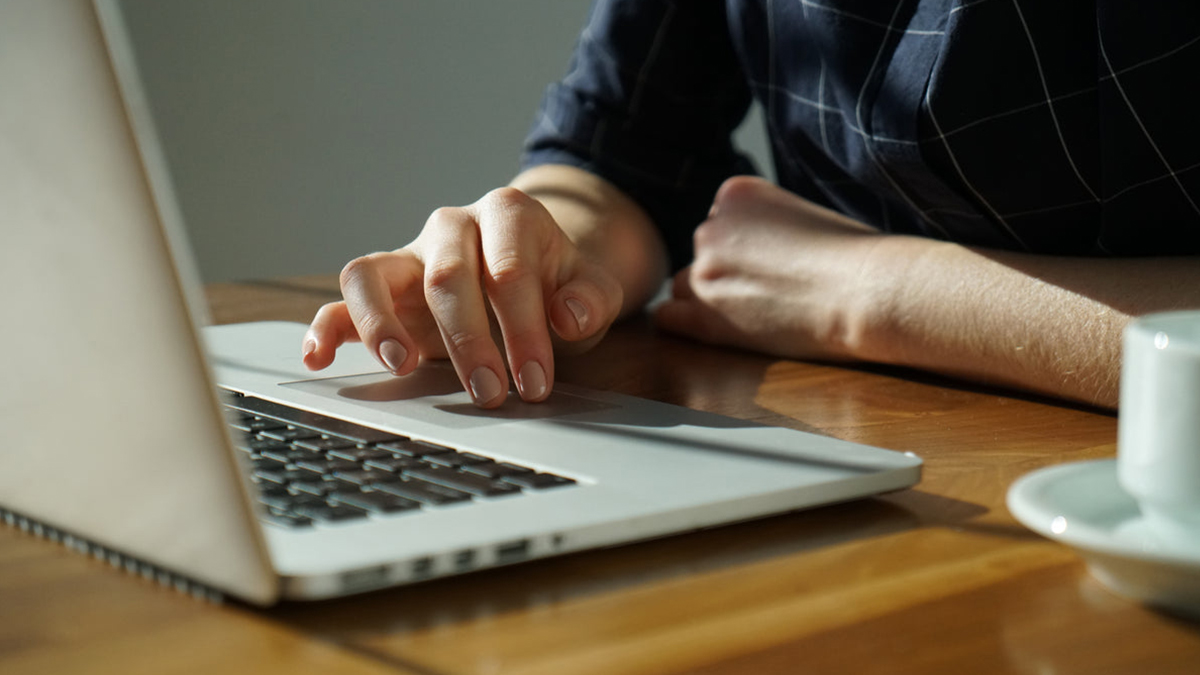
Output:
[{"xmin": 522, "ymin": 0, "xmax": 1200, "ymax": 265}]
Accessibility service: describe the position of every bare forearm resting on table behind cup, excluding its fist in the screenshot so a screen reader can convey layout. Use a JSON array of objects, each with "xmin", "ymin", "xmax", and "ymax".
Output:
[{"xmin": 856, "ymin": 237, "xmax": 1200, "ymax": 408}]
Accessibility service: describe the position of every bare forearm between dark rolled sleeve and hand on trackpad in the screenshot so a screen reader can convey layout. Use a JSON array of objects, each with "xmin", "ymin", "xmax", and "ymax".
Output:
[{"xmin": 511, "ymin": 165, "xmax": 668, "ymax": 316}]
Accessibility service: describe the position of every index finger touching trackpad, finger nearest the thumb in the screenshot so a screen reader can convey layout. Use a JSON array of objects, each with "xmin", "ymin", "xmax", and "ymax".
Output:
[{"xmin": 472, "ymin": 190, "xmax": 557, "ymax": 401}]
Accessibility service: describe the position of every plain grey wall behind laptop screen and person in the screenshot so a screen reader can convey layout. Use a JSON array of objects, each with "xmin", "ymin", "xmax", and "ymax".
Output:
[{"xmin": 124, "ymin": 0, "xmax": 763, "ymax": 281}]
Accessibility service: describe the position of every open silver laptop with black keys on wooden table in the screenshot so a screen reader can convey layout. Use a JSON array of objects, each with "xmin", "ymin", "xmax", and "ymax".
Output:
[{"xmin": 0, "ymin": 0, "xmax": 922, "ymax": 605}]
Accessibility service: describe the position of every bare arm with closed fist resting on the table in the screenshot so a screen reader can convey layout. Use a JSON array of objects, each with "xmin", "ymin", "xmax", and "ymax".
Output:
[{"xmin": 658, "ymin": 172, "xmax": 1200, "ymax": 407}]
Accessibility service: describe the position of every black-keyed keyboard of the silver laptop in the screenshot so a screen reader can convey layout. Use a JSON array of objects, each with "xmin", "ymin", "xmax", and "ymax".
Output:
[{"xmin": 224, "ymin": 392, "xmax": 575, "ymax": 527}]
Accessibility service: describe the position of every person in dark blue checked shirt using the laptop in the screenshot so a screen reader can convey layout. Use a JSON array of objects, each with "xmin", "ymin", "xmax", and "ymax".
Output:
[{"xmin": 302, "ymin": 0, "xmax": 1200, "ymax": 407}]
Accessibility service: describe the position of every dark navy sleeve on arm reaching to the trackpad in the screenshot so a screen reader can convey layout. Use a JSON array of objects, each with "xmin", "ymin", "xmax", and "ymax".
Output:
[{"xmin": 521, "ymin": 0, "xmax": 754, "ymax": 269}]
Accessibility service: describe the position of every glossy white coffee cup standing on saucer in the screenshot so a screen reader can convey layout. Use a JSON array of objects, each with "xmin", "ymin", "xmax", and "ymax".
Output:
[{"xmin": 1117, "ymin": 311, "xmax": 1200, "ymax": 548}]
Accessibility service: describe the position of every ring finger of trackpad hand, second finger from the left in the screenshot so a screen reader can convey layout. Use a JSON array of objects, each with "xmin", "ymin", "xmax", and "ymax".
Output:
[{"xmin": 341, "ymin": 250, "xmax": 421, "ymax": 375}]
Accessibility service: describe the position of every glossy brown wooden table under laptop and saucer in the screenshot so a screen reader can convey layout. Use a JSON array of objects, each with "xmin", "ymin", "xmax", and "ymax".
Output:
[{"xmin": 0, "ymin": 277, "xmax": 1200, "ymax": 675}]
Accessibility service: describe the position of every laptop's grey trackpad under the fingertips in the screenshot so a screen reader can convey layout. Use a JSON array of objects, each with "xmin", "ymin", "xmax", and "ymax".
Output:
[{"xmin": 281, "ymin": 362, "xmax": 617, "ymax": 426}]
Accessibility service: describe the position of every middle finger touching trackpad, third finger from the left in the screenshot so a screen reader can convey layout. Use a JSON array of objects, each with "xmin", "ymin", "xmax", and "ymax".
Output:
[{"xmin": 421, "ymin": 209, "xmax": 509, "ymax": 408}]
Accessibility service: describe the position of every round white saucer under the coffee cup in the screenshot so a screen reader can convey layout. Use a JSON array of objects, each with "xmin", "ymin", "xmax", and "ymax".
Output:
[{"xmin": 1008, "ymin": 460, "xmax": 1200, "ymax": 617}]
